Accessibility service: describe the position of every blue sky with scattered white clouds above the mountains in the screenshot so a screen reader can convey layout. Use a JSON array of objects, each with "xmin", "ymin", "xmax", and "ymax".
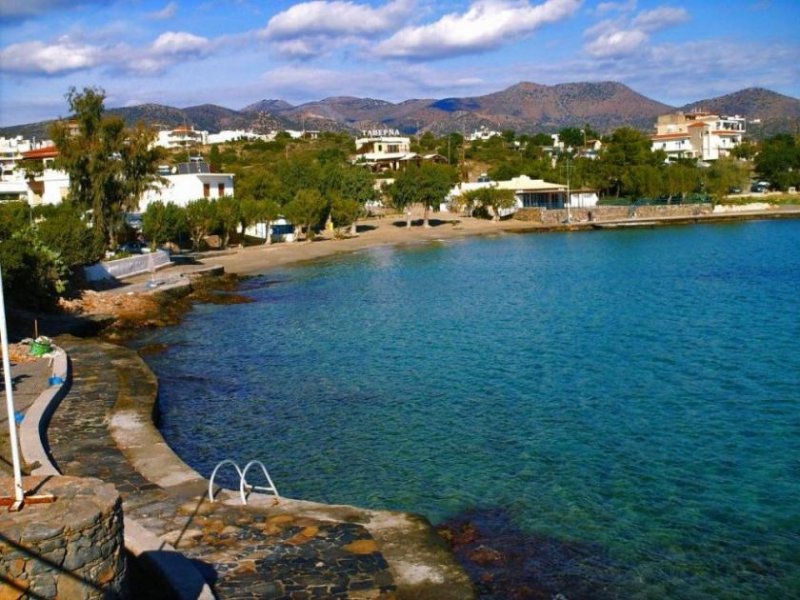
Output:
[{"xmin": 0, "ymin": 0, "xmax": 800, "ymax": 125}]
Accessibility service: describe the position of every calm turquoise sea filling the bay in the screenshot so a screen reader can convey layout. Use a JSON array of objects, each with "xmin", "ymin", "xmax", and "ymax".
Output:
[{"xmin": 140, "ymin": 221, "xmax": 800, "ymax": 599}]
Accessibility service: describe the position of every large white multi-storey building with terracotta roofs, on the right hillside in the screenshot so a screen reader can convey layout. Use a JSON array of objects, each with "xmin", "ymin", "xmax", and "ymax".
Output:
[{"xmin": 650, "ymin": 111, "xmax": 746, "ymax": 160}]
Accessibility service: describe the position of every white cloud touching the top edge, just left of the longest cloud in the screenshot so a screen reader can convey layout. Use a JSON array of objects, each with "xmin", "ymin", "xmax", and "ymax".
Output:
[{"xmin": 262, "ymin": 0, "xmax": 413, "ymax": 40}]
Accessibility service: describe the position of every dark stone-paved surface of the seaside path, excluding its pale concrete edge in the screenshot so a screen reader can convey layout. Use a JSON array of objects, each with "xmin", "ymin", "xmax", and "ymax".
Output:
[{"xmin": 48, "ymin": 339, "xmax": 396, "ymax": 599}]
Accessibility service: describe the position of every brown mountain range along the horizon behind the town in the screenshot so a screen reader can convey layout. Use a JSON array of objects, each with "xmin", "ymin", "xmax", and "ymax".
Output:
[{"xmin": 0, "ymin": 82, "xmax": 800, "ymax": 138}]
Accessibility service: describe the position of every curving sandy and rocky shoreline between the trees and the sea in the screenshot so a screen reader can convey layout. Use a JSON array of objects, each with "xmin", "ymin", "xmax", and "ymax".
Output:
[{"xmin": 56, "ymin": 206, "xmax": 800, "ymax": 343}]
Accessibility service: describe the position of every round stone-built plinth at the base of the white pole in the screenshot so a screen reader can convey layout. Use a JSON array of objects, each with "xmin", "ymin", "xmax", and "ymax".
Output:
[{"xmin": 0, "ymin": 477, "xmax": 126, "ymax": 600}]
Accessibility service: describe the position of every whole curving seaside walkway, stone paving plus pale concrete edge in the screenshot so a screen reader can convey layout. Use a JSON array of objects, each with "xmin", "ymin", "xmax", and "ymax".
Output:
[{"xmin": 42, "ymin": 337, "xmax": 473, "ymax": 600}]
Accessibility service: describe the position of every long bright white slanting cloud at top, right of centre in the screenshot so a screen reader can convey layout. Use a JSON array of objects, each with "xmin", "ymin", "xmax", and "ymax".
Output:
[{"xmin": 376, "ymin": 0, "xmax": 582, "ymax": 59}]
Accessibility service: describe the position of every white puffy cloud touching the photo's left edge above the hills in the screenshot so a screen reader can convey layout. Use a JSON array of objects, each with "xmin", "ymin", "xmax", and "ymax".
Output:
[{"xmin": 0, "ymin": 37, "xmax": 103, "ymax": 75}]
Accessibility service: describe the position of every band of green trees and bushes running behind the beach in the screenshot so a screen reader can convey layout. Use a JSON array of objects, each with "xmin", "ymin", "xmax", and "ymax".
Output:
[{"xmin": 0, "ymin": 88, "xmax": 800, "ymax": 305}]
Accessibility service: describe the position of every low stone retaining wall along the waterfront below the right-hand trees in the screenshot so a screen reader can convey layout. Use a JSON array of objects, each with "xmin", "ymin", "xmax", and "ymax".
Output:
[{"xmin": 514, "ymin": 204, "xmax": 713, "ymax": 225}]
